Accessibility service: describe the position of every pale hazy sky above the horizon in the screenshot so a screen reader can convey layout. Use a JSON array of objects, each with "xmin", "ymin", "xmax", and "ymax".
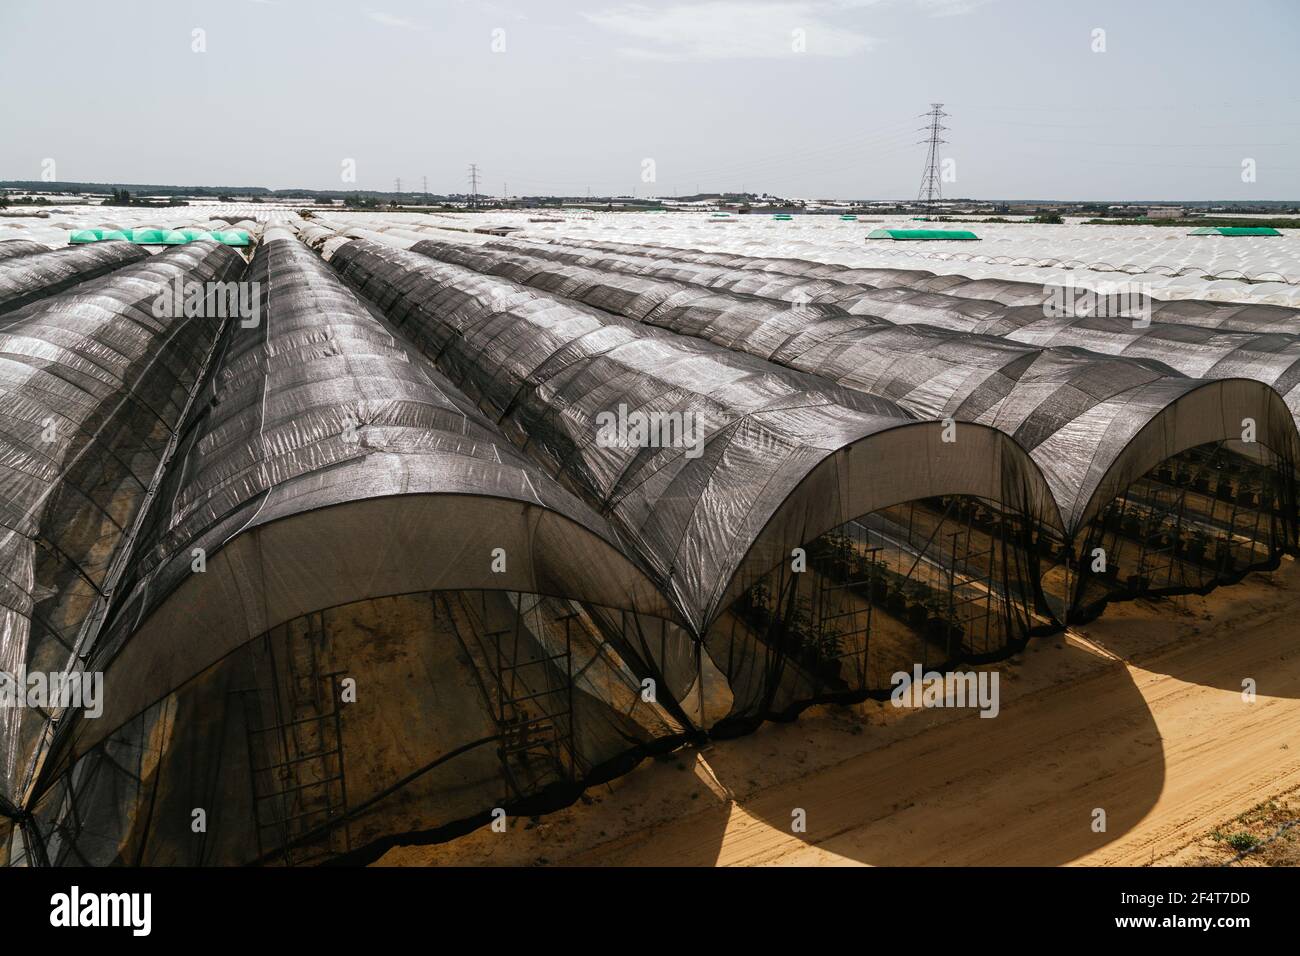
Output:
[{"xmin": 0, "ymin": 0, "xmax": 1300, "ymax": 200}]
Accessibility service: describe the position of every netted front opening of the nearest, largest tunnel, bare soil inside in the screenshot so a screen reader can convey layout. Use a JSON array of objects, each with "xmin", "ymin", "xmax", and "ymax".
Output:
[{"xmin": 22, "ymin": 589, "xmax": 702, "ymax": 866}]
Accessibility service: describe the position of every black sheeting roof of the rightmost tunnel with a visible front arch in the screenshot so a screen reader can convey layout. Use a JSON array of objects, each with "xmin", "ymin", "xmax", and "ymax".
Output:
[{"xmin": 411, "ymin": 241, "xmax": 1300, "ymax": 537}]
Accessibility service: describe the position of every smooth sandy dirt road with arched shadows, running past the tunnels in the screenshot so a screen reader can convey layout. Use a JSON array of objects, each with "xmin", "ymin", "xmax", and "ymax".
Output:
[{"xmin": 559, "ymin": 590, "xmax": 1300, "ymax": 866}]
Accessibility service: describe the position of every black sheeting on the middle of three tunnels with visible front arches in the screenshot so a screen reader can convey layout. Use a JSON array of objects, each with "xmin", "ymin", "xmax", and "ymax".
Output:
[{"xmin": 332, "ymin": 241, "xmax": 1058, "ymax": 734}]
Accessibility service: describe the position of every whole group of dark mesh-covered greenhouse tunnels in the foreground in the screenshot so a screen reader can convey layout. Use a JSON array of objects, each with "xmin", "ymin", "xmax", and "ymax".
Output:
[{"xmin": 0, "ymin": 223, "xmax": 1300, "ymax": 865}]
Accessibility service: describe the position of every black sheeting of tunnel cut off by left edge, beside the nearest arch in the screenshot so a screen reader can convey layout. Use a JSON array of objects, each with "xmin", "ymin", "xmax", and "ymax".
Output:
[{"xmin": 0, "ymin": 242, "xmax": 243, "ymax": 808}]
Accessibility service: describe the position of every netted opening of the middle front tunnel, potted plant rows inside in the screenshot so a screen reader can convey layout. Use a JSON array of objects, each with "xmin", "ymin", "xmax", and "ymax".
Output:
[{"xmin": 709, "ymin": 496, "xmax": 1034, "ymax": 719}]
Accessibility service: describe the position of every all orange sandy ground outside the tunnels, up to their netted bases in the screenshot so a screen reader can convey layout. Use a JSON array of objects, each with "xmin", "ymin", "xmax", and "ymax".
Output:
[{"xmin": 380, "ymin": 561, "xmax": 1300, "ymax": 866}]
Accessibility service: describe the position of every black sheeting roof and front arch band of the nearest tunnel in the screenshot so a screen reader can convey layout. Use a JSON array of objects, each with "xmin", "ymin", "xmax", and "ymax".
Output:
[{"xmin": 63, "ymin": 230, "xmax": 671, "ymax": 724}]
